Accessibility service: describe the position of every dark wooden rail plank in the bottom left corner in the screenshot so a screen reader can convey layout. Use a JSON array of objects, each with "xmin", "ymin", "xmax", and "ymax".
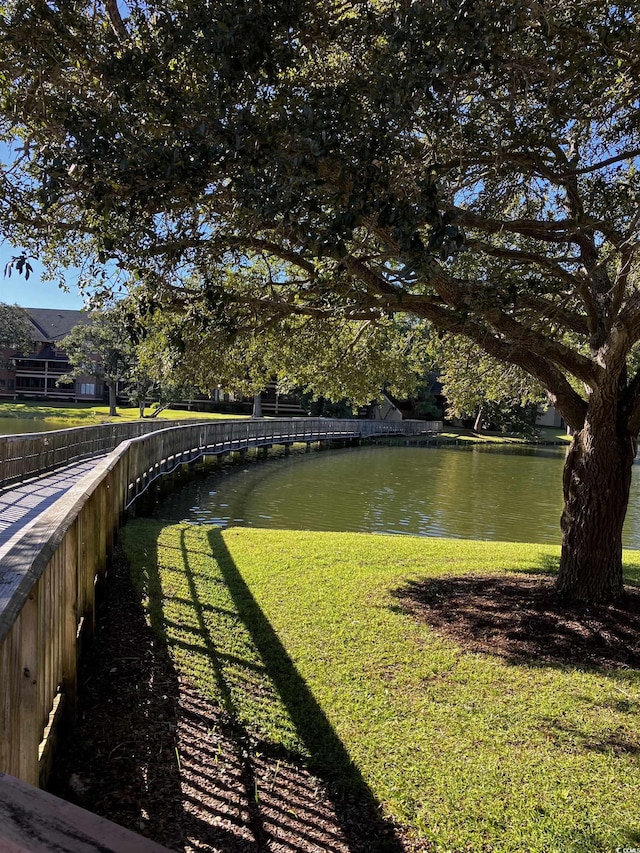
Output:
[{"xmin": 0, "ymin": 773, "xmax": 172, "ymax": 853}]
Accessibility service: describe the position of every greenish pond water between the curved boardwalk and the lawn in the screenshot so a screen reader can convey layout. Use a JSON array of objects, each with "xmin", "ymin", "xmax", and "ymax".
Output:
[{"xmin": 154, "ymin": 445, "xmax": 640, "ymax": 548}]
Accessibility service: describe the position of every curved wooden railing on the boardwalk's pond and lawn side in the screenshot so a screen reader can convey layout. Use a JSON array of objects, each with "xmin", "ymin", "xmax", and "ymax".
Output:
[{"xmin": 0, "ymin": 419, "xmax": 441, "ymax": 785}]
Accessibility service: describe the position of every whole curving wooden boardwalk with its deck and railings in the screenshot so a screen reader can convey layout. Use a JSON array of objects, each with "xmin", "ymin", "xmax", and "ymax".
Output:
[{"xmin": 0, "ymin": 418, "xmax": 442, "ymax": 853}]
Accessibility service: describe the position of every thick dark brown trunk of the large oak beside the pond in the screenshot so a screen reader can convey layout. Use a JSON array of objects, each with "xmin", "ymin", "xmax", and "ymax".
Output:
[{"xmin": 556, "ymin": 422, "xmax": 637, "ymax": 603}]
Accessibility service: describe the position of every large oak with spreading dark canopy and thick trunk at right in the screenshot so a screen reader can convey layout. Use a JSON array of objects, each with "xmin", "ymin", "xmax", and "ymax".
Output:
[{"xmin": 0, "ymin": 0, "xmax": 640, "ymax": 600}]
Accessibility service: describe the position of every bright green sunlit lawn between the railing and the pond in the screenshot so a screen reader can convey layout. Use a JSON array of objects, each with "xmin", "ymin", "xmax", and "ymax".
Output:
[{"xmin": 123, "ymin": 519, "xmax": 640, "ymax": 853}]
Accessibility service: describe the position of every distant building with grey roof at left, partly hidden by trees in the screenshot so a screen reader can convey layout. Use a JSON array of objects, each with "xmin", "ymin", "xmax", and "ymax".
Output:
[{"xmin": 0, "ymin": 308, "xmax": 104, "ymax": 401}]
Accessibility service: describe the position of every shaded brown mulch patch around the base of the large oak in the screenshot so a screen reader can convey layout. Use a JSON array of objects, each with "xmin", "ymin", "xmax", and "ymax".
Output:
[{"xmin": 396, "ymin": 574, "xmax": 640, "ymax": 668}]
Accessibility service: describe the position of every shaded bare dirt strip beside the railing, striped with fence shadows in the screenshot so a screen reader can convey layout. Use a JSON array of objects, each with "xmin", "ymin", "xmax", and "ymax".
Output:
[{"xmin": 49, "ymin": 554, "xmax": 410, "ymax": 853}]
